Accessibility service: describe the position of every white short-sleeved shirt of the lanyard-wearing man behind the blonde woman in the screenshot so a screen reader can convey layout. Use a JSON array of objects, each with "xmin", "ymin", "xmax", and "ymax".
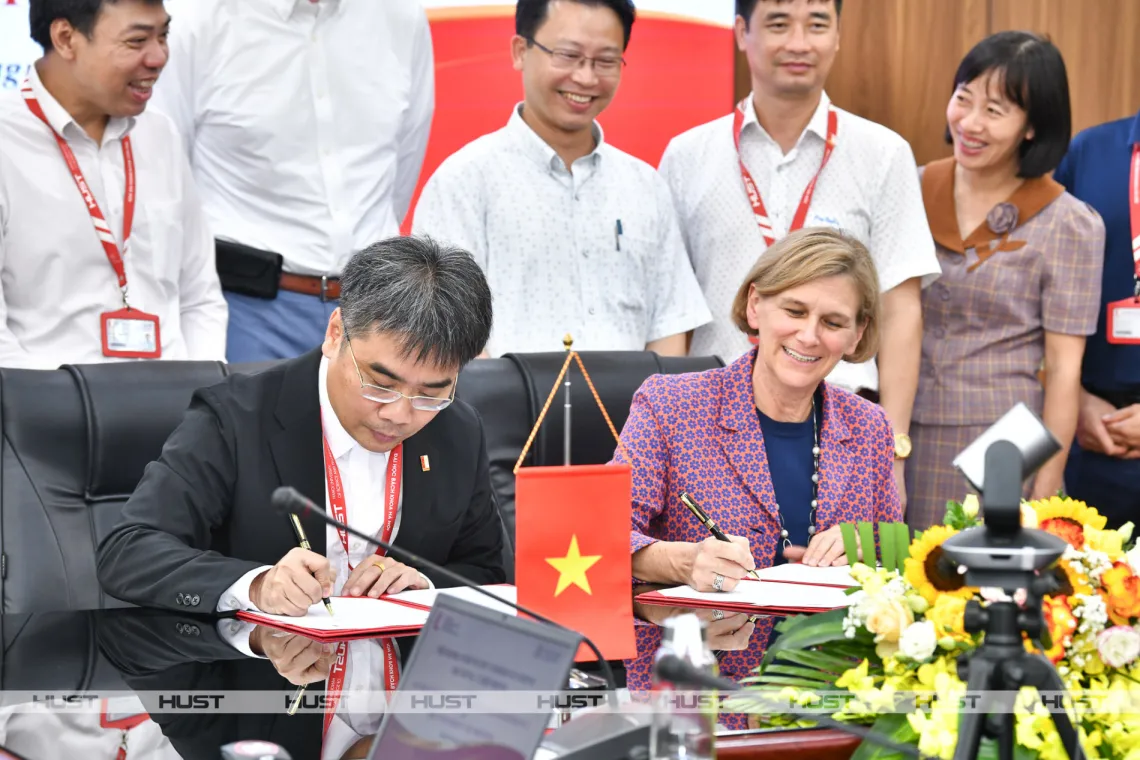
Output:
[{"xmin": 660, "ymin": 93, "xmax": 942, "ymax": 390}]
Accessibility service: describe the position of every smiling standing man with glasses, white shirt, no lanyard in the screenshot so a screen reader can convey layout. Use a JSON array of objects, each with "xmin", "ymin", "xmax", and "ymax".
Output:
[{"xmin": 413, "ymin": 0, "xmax": 710, "ymax": 356}]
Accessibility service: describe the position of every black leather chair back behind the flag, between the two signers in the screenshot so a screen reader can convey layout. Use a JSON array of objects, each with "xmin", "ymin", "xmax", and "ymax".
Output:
[{"xmin": 456, "ymin": 351, "xmax": 724, "ymax": 553}]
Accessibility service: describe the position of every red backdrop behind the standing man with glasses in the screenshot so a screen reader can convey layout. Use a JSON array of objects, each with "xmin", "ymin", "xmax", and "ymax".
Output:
[{"xmin": 404, "ymin": 9, "xmax": 733, "ymax": 232}]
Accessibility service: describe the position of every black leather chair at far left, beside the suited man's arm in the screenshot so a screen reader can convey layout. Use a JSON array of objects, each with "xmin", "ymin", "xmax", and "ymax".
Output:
[{"xmin": 0, "ymin": 361, "xmax": 227, "ymax": 613}]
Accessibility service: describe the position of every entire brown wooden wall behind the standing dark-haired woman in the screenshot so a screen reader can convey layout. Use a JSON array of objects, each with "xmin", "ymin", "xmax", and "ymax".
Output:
[{"xmin": 726, "ymin": 0, "xmax": 1140, "ymax": 164}]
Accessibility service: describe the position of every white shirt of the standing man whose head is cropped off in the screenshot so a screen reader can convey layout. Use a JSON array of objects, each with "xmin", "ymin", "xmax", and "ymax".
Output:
[{"xmin": 154, "ymin": 0, "xmax": 435, "ymax": 275}]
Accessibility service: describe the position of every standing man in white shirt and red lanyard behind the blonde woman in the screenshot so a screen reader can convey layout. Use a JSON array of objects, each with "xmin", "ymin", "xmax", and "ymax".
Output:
[{"xmin": 660, "ymin": 0, "xmax": 941, "ymax": 510}]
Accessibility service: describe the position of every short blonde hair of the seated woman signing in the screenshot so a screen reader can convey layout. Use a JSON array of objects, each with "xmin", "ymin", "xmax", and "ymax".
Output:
[{"xmin": 732, "ymin": 227, "xmax": 881, "ymax": 362}]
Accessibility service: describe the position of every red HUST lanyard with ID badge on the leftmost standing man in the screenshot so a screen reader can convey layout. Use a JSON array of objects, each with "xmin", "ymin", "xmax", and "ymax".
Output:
[{"xmin": 19, "ymin": 80, "xmax": 162, "ymax": 359}]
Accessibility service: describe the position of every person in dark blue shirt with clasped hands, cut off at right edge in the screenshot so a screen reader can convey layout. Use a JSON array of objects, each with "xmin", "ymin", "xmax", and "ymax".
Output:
[{"xmin": 1053, "ymin": 107, "xmax": 1140, "ymax": 528}]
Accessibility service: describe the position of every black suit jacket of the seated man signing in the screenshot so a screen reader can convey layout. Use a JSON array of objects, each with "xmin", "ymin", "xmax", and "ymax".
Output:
[{"xmin": 98, "ymin": 351, "xmax": 506, "ymax": 613}]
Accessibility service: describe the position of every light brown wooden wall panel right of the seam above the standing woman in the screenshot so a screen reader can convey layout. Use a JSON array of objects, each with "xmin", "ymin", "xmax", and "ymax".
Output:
[{"xmin": 990, "ymin": 0, "xmax": 1140, "ymax": 133}]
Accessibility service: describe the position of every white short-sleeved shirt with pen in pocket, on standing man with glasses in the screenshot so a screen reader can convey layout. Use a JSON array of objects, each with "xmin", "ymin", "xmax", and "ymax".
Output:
[{"xmin": 414, "ymin": 104, "xmax": 710, "ymax": 356}]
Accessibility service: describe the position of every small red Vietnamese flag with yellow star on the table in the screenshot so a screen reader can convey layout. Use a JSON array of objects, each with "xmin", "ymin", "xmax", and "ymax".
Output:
[{"xmin": 515, "ymin": 465, "xmax": 637, "ymax": 660}]
